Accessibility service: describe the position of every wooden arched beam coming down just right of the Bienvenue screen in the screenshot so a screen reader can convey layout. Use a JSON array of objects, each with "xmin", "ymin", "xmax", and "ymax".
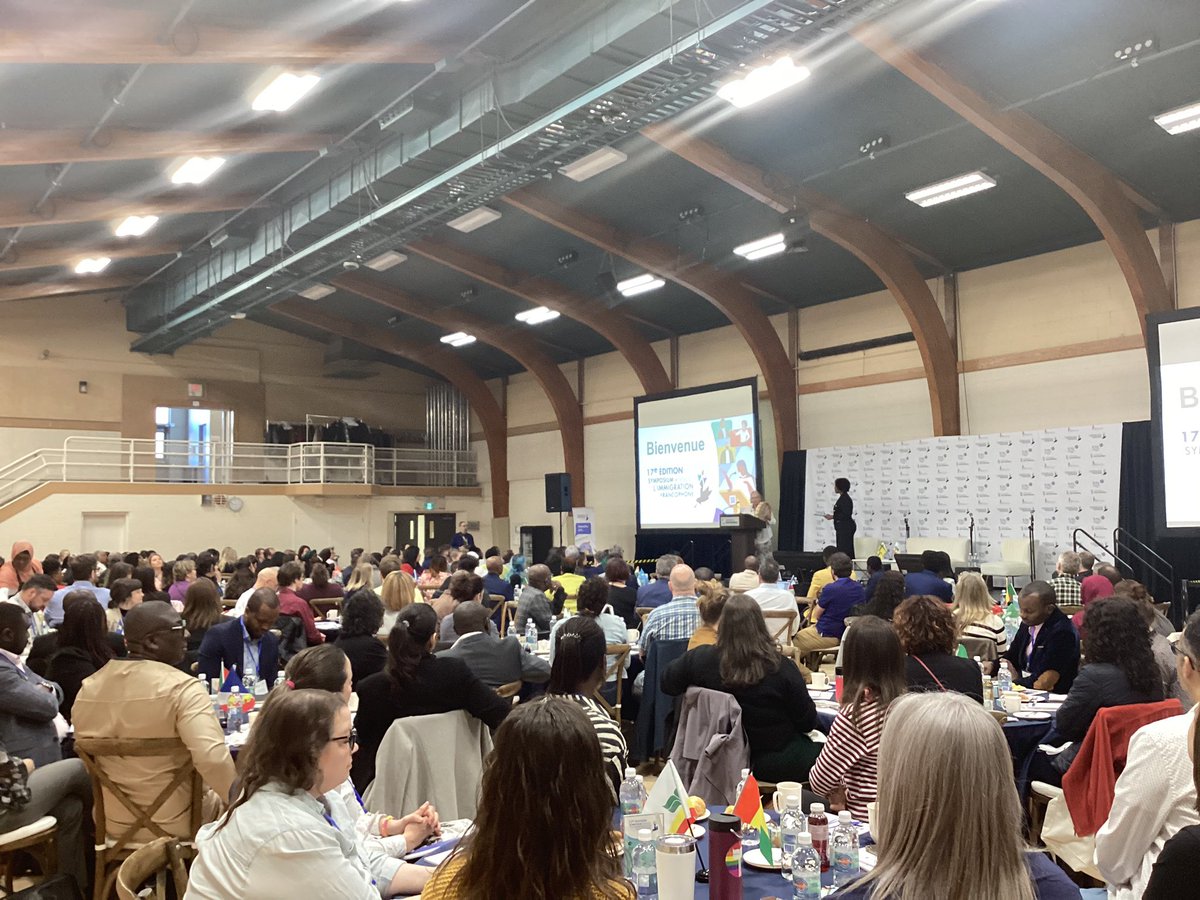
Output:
[{"xmin": 504, "ymin": 187, "xmax": 799, "ymax": 464}]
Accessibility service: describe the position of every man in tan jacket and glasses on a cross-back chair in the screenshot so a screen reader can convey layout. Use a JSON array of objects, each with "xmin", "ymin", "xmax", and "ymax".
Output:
[{"xmin": 71, "ymin": 600, "xmax": 236, "ymax": 840}]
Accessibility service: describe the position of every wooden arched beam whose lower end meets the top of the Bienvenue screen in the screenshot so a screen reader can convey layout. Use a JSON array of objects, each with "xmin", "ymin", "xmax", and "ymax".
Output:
[{"xmin": 404, "ymin": 239, "xmax": 673, "ymax": 394}]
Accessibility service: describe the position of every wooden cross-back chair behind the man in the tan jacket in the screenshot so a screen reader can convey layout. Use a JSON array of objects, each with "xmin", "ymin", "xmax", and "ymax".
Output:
[{"xmin": 76, "ymin": 736, "xmax": 204, "ymax": 900}]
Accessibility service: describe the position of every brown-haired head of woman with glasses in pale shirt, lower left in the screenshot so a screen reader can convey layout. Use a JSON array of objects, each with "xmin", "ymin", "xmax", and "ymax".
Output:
[{"xmin": 220, "ymin": 685, "xmax": 346, "ymax": 828}]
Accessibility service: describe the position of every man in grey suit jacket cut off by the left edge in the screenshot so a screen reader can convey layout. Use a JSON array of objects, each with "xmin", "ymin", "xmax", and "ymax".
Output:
[{"xmin": 0, "ymin": 601, "xmax": 63, "ymax": 766}]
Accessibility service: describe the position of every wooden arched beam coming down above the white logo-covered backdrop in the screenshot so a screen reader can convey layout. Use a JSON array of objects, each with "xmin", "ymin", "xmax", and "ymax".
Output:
[{"xmin": 642, "ymin": 125, "xmax": 960, "ymax": 436}]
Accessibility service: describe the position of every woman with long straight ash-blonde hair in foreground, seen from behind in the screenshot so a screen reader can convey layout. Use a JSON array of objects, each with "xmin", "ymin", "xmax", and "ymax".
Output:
[{"xmin": 834, "ymin": 692, "xmax": 1079, "ymax": 900}]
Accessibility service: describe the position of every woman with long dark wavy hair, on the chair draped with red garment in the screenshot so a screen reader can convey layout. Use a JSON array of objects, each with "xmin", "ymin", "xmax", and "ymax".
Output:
[{"xmin": 1030, "ymin": 596, "xmax": 1163, "ymax": 785}]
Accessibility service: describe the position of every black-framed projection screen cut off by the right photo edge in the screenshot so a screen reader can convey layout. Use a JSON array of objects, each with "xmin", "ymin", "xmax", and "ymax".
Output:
[{"xmin": 1146, "ymin": 308, "xmax": 1200, "ymax": 536}]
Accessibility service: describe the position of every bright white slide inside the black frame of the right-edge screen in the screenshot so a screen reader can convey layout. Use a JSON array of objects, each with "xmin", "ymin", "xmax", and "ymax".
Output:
[{"xmin": 1156, "ymin": 318, "xmax": 1200, "ymax": 528}]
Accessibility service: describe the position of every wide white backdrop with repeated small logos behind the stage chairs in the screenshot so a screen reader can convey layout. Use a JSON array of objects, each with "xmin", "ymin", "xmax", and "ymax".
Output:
[{"xmin": 804, "ymin": 425, "xmax": 1121, "ymax": 577}]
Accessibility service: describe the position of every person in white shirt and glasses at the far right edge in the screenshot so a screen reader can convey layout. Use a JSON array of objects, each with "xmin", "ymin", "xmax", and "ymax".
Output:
[{"xmin": 1096, "ymin": 612, "xmax": 1200, "ymax": 900}]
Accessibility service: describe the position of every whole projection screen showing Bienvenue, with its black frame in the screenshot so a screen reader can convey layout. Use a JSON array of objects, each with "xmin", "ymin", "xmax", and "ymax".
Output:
[{"xmin": 634, "ymin": 378, "xmax": 762, "ymax": 530}]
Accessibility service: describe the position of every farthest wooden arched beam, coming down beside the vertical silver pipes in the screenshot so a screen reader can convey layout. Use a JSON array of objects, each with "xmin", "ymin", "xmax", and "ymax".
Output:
[{"xmin": 271, "ymin": 299, "xmax": 509, "ymax": 518}]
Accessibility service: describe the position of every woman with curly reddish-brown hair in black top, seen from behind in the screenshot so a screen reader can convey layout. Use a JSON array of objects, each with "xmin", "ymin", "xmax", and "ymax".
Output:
[{"xmin": 893, "ymin": 595, "xmax": 983, "ymax": 703}]
